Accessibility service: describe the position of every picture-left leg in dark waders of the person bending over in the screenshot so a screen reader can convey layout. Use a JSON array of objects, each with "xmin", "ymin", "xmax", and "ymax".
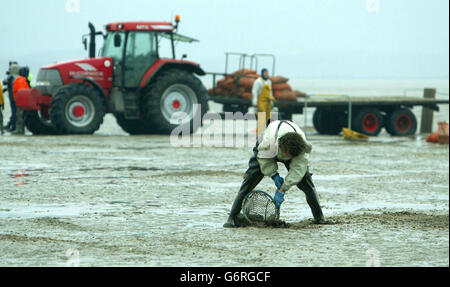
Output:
[{"xmin": 223, "ymin": 145, "xmax": 264, "ymax": 227}]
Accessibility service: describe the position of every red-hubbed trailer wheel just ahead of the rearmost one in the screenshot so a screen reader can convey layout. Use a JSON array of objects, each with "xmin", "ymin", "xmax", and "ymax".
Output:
[{"xmin": 352, "ymin": 108, "xmax": 384, "ymax": 136}]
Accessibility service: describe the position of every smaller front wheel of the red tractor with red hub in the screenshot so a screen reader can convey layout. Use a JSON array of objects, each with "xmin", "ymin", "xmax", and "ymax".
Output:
[{"xmin": 50, "ymin": 84, "xmax": 105, "ymax": 134}]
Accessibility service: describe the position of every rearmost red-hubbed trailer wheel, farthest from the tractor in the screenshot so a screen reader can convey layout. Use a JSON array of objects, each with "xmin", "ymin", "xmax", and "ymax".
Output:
[{"xmin": 386, "ymin": 109, "xmax": 417, "ymax": 136}]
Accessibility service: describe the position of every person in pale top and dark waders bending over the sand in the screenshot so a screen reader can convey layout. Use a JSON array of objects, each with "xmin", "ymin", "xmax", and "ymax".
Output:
[{"xmin": 223, "ymin": 121, "xmax": 327, "ymax": 227}]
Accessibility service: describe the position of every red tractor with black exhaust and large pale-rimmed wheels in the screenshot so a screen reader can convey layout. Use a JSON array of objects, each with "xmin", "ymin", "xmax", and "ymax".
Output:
[{"xmin": 17, "ymin": 16, "xmax": 208, "ymax": 134}]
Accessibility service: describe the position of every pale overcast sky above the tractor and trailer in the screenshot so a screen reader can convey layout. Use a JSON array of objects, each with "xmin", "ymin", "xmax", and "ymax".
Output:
[{"xmin": 0, "ymin": 0, "xmax": 449, "ymax": 79}]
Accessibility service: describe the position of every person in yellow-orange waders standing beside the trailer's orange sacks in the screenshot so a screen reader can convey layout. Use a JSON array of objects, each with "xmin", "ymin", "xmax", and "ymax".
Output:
[{"xmin": 252, "ymin": 69, "xmax": 275, "ymax": 137}]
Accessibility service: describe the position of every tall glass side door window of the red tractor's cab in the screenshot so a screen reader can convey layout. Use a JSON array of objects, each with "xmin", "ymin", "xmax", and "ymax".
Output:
[{"xmin": 125, "ymin": 31, "xmax": 158, "ymax": 87}]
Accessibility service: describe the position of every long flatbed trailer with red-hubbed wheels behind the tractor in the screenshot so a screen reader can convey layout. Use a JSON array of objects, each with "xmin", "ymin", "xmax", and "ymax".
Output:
[{"xmin": 210, "ymin": 92, "xmax": 449, "ymax": 136}]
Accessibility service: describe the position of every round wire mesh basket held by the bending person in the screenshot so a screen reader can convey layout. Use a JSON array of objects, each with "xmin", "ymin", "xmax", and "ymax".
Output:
[{"xmin": 242, "ymin": 191, "xmax": 280, "ymax": 223}]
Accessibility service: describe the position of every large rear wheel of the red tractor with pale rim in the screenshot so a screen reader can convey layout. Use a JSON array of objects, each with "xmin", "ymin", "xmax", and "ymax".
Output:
[{"xmin": 142, "ymin": 69, "xmax": 208, "ymax": 134}]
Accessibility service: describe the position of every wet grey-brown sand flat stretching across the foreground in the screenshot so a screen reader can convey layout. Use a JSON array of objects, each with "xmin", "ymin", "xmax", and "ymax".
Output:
[{"xmin": 0, "ymin": 81, "xmax": 449, "ymax": 266}]
